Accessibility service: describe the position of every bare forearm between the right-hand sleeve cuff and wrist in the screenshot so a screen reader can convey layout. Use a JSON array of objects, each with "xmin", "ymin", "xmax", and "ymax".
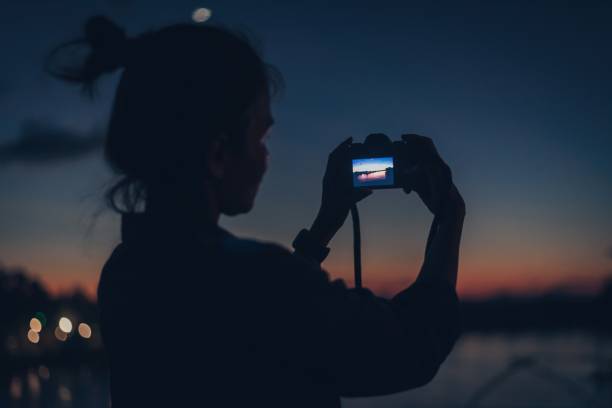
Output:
[{"xmin": 417, "ymin": 216, "xmax": 463, "ymax": 287}]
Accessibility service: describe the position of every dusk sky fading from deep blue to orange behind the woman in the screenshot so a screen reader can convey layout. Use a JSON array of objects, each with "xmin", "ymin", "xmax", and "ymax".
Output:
[{"xmin": 0, "ymin": 0, "xmax": 612, "ymax": 297}]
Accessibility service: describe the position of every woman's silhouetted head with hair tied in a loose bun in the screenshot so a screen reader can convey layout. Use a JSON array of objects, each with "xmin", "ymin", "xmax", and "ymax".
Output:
[{"xmin": 48, "ymin": 17, "xmax": 282, "ymax": 215}]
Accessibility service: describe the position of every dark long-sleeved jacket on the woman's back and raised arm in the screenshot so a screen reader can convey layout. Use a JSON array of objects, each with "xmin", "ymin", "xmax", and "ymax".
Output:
[{"xmin": 98, "ymin": 214, "xmax": 459, "ymax": 408}]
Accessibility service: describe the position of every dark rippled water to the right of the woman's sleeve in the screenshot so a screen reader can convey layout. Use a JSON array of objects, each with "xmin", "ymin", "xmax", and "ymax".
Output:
[{"xmin": 343, "ymin": 332, "xmax": 612, "ymax": 408}]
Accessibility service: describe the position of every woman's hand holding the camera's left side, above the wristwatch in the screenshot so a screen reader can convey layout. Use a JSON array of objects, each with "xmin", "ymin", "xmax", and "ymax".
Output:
[{"xmin": 310, "ymin": 137, "xmax": 372, "ymax": 245}]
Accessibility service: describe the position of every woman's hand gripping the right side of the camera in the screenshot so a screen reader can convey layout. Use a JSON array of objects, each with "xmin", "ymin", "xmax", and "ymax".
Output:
[{"xmin": 402, "ymin": 134, "xmax": 465, "ymax": 221}]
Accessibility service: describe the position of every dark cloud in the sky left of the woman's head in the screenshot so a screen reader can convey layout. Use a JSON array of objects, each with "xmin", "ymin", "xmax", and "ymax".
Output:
[{"xmin": 0, "ymin": 120, "xmax": 104, "ymax": 165}]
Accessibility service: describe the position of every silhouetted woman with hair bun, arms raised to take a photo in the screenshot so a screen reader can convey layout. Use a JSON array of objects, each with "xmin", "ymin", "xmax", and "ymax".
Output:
[{"xmin": 49, "ymin": 17, "xmax": 465, "ymax": 408}]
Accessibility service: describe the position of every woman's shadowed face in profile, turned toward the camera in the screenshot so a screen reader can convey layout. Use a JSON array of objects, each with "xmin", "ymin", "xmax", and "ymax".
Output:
[{"xmin": 219, "ymin": 92, "xmax": 274, "ymax": 215}]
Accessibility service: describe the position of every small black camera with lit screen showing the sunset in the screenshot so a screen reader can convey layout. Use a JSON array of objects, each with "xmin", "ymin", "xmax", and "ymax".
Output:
[{"xmin": 349, "ymin": 133, "xmax": 406, "ymax": 189}]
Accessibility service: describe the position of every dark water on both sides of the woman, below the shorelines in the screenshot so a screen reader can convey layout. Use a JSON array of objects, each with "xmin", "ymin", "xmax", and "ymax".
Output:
[{"xmin": 5, "ymin": 332, "xmax": 612, "ymax": 408}]
